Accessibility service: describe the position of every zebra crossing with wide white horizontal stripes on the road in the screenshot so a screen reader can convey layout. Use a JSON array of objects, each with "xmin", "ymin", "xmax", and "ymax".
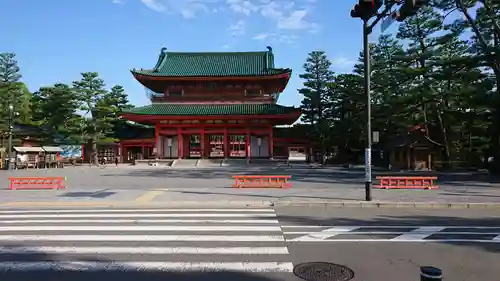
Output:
[{"xmin": 0, "ymin": 208, "xmax": 293, "ymax": 273}]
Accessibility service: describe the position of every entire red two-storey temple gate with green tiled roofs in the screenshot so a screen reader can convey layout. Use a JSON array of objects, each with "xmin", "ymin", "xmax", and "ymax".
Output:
[{"xmin": 120, "ymin": 47, "xmax": 307, "ymax": 162}]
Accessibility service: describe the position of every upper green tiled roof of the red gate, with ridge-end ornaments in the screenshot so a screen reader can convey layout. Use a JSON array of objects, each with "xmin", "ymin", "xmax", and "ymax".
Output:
[{"xmin": 131, "ymin": 47, "xmax": 291, "ymax": 77}]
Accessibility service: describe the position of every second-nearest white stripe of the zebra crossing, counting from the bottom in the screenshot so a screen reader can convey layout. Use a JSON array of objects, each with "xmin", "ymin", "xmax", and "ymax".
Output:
[{"xmin": 0, "ymin": 247, "xmax": 288, "ymax": 255}]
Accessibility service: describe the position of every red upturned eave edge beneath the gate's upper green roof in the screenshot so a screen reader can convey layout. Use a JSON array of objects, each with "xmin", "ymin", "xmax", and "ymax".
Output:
[{"xmin": 130, "ymin": 69, "xmax": 292, "ymax": 82}]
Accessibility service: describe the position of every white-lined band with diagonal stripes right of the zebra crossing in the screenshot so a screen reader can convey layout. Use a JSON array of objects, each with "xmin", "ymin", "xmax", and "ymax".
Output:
[{"xmin": 281, "ymin": 225, "xmax": 500, "ymax": 243}]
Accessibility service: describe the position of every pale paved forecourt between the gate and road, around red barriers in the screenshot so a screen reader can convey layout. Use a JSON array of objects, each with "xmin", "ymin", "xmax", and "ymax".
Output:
[{"xmin": 0, "ymin": 166, "xmax": 500, "ymax": 204}]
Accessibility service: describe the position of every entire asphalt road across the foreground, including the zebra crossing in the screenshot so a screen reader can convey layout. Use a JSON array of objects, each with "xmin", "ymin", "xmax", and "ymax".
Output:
[{"xmin": 0, "ymin": 207, "xmax": 500, "ymax": 281}]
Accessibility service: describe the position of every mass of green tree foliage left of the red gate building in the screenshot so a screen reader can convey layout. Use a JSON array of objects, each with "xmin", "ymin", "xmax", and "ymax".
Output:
[{"xmin": 0, "ymin": 53, "xmax": 132, "ymax": 161}]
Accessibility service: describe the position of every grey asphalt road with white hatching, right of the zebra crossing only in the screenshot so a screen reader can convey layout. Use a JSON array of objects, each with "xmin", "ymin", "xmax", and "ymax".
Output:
[{"xmin": 276, "ymin": 208, "xmax": 500, "ymax": 281}]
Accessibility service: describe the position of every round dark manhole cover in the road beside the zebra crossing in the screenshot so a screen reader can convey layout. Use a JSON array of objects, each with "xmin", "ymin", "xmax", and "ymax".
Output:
[{"xmin": 293, "ymin": 262, "xmax": 354, "ymax": 281}]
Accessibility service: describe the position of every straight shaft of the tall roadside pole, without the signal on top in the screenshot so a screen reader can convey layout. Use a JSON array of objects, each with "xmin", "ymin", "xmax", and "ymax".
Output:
[{"xmin": 363, "ymin": 20, "xmax": 372, "ymax": 201}]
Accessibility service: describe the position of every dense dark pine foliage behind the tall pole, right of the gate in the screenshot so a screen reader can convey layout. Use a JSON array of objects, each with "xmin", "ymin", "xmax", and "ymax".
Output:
[{"xmin": 296, "ymin": 0, "xmax": 500, "ymax": 171}]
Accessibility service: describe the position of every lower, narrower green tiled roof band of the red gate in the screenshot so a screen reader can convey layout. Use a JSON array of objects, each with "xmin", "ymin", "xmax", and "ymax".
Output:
[{"xmin": 124, "ymin": 103, "xmax": 299, "ymax": 116}]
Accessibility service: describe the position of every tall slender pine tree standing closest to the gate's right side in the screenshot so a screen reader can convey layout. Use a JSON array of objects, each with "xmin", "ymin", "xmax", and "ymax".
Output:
[{"xmin": 298, "ymin": 51, "xmax": 334, "ymax": 162}]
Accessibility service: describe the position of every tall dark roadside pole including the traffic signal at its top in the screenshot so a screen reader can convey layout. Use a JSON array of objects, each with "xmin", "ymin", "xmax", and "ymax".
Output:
[{"xmin": 351, "ymin": 0, "xmax": 428, "ymax": 201}]
